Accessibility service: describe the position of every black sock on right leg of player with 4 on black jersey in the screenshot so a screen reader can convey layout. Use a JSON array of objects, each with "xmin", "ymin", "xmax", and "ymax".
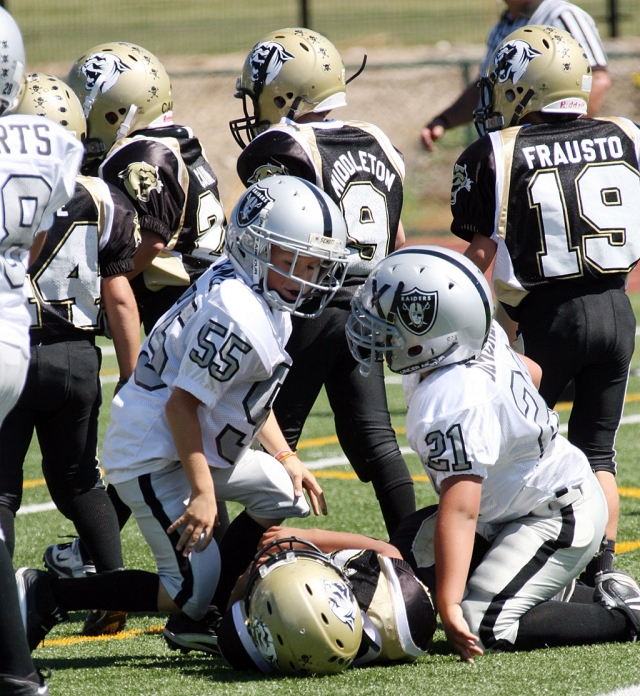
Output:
[{"xmin": 68, "ymin": 488, "xmax": 124, "ymax": 573}]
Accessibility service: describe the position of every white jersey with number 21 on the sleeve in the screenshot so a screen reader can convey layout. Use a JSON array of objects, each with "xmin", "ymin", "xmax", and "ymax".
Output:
[{"xmin": 403, "ymin": 322, "xmax": 591, "ymax": 523}]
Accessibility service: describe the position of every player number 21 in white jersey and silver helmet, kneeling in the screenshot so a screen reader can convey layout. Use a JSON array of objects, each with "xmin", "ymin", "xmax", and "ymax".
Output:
[{"xmin": 347, "ymin": 246, "xmax": 640, "ymax": 661}]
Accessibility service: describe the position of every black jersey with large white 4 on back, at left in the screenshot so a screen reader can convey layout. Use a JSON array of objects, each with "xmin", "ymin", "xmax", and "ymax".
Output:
[{"xmin": 28, "ymin": 176, "xmax": 140, "ymax": 343}]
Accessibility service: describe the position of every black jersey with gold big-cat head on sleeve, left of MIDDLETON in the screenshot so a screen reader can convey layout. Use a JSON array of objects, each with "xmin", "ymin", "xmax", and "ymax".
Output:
[{"xmin": 99, "ymin": 125, "xmax": 225, "ymax": 290}]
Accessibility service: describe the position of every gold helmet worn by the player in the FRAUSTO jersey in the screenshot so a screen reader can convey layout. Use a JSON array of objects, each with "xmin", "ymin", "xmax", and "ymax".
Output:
[{"xmin": 474, "ymin": 25, "xmax": 592, "ymax": 135}]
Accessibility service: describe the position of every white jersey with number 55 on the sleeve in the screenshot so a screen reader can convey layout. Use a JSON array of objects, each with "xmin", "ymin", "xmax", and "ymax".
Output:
[{"xmin": 103, "ymin": 256, "xmax": 291, "ymax": 483}]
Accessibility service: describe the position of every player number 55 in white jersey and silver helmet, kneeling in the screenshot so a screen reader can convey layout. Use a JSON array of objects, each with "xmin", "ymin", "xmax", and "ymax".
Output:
[{"xmin": 17, "ymin": 177, "xmax": 346, "ymax": 649}]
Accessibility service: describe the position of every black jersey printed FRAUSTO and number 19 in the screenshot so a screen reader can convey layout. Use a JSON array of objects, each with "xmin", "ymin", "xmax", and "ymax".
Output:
[{"xmin": 451, "ymin": 118, "xmax": 640, "ymax": 307}]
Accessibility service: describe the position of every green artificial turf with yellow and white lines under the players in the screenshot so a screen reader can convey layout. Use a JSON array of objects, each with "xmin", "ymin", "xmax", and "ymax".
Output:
[{"xmin": 14, "ymin": 293, "xmax": 640, "ymax": 696}]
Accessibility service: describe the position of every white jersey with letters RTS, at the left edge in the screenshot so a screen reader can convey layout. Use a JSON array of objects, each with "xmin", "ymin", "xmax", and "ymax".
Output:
[{"xmin": 0, "ymin": 115, "xmax": 84, "ymax": 350}]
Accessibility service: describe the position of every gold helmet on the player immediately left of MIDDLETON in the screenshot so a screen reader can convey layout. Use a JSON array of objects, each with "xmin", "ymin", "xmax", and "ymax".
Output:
[{"xmin": 67, "ymin": 42, "xmax": 173, "ymax": 154}]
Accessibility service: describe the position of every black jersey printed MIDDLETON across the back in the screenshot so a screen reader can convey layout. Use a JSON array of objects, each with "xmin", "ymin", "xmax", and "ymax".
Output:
[{"xmin": 237, "ymin": 121, "xmax": 404, "ymax": 280}]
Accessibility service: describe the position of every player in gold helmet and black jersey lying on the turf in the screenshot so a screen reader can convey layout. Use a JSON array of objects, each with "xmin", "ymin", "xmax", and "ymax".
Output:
[{"xmin": 218, "ymin": 527, "xmax": 436, "ymax": 676}]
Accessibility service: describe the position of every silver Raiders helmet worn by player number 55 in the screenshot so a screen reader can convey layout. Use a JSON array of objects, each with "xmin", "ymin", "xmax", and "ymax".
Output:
[{"xmin": 226, "ymin": 176, "xmax": 348, "ymax": 317}]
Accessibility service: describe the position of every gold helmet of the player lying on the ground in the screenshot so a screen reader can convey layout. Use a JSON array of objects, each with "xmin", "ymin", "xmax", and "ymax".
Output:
[{"xmin": 218, "ymin": 537, "xmax": 363, "ymax": 676}]
